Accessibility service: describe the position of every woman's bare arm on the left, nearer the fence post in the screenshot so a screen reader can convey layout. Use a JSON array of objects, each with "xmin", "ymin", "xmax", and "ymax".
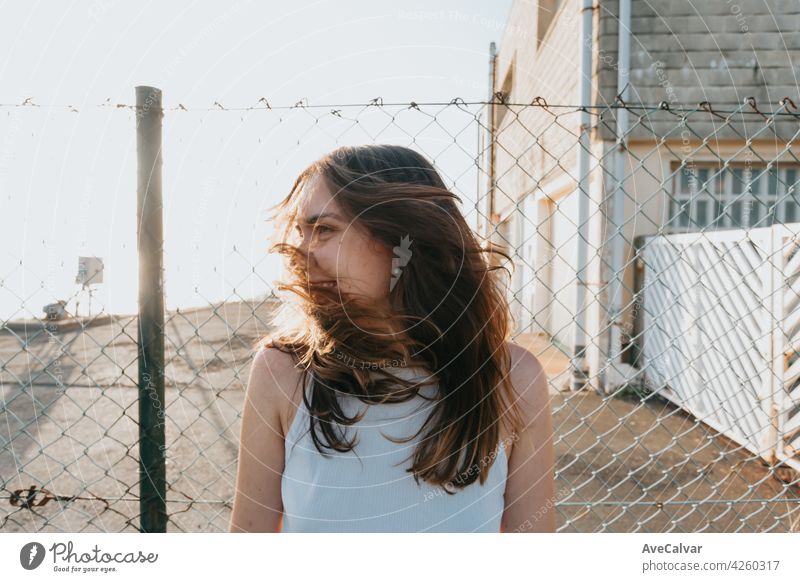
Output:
[{"xmin": 229, "ymin": 348, "xmax": 292, "ymax": 532}]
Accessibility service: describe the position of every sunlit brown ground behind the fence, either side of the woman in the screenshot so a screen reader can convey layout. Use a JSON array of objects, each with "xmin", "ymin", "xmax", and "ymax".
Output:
[{"xmin": 0, "ymin": 302, "xmax": 800, "ymax": 532}]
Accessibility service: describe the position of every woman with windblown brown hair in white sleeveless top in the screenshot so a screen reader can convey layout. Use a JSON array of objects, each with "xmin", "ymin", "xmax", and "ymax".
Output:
[{"xmin": 230, "ymin": 145, "xmax": 555, "ymax": 532}]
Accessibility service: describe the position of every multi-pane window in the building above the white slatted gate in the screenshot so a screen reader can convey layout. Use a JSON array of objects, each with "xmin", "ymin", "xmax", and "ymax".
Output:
[{"xmin": 667, "ymin": 163, "xmax": 800, "ymax": 232}]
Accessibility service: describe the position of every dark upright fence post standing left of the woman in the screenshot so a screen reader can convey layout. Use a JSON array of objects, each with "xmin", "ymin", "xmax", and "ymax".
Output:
[{"xmin": 136, "ymin": 86, "xmax": 167, "ymax": 532}]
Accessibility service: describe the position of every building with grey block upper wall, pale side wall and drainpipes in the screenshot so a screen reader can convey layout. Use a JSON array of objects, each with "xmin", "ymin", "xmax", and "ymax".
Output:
[{"xmin": 482, "ymin": 0, "xmax": 800, "ymax": 390}]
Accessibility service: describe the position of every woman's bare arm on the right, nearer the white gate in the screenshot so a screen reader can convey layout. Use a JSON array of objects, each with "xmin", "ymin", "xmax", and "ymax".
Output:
[{"xmin": 501, "ymin": 344, "xmax": 556, "ymax": 533}]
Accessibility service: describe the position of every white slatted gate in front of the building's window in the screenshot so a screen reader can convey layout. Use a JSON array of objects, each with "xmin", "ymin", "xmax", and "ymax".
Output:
[{"xmin": 639, "ymin": 223, "xmax": 800, "ymax": 470}]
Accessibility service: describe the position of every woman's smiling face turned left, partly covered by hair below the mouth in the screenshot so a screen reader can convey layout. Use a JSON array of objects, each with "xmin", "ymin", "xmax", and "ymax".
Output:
[{"xmin": 293, "ymin": 176, "xmax": 393, "ymax": 305}]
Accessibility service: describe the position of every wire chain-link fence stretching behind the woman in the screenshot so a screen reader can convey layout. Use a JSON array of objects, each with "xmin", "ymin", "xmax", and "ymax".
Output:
[{"xmin": 0, "ymin": 95, "xmax": 800, "ymax": 532}]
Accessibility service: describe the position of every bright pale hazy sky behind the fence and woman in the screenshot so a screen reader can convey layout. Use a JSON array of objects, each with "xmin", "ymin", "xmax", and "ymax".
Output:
[{"xmin": 0, "ymin": 0, "xmax": 511, "ymax": 320}]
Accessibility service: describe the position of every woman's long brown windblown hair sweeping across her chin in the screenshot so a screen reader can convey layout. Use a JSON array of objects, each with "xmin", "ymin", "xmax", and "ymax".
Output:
[{"xmin": 254, "ymin": 145, "xmax": 520, "ymax": 493}]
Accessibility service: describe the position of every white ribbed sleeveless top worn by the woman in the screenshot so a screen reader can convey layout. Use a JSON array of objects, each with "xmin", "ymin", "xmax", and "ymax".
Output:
[{"xmin": 281, "ymin": 368, "xmax": 508, "ymax": 533}]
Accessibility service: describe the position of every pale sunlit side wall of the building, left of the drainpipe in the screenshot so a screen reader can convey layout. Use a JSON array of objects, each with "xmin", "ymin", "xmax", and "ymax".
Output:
[{"xmin": 495, "ymin": 1, "xmax": 600, "ymax": 364}]
